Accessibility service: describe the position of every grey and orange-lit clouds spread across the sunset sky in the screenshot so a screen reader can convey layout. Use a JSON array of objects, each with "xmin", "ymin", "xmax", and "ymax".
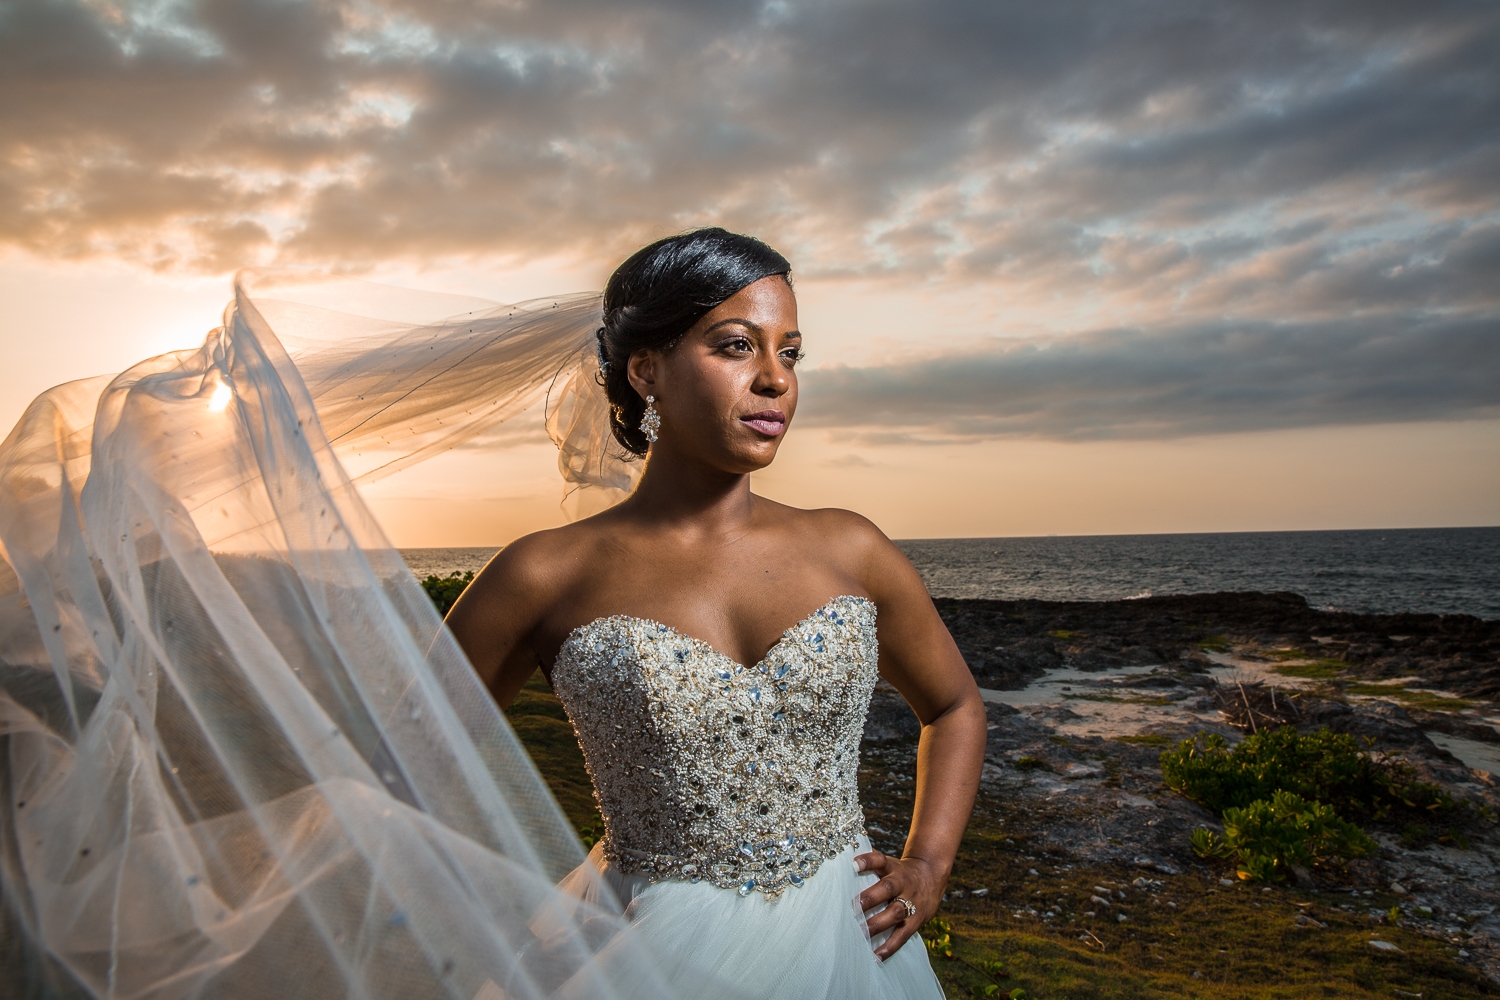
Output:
[{"xmin": 0, "ymin": 0, "xmax": 1500, "ymax": 436}]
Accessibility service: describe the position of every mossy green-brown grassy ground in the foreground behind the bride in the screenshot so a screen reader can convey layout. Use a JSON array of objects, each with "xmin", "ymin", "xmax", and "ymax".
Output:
[{"xmin": 506, "ymin": 675, "xmax": 1500, "ymax": 1000}]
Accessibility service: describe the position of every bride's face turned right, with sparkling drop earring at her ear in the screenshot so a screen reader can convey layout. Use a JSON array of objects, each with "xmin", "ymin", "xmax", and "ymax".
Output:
[{"xmin": 630, "ymin": 276, "xmax": 803, "ymax": 474}]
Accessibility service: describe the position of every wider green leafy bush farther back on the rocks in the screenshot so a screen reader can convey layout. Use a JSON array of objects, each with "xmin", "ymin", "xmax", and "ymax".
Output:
[{"xmin": 1161, "ymin": 726, "xmax": 1458, "ymax": 822}]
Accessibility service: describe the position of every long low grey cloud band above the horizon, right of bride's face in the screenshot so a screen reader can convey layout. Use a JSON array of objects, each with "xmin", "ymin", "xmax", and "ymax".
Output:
[{"xmin": 797, "ymin": 315, "xmax": 1500, "ymax": 442}]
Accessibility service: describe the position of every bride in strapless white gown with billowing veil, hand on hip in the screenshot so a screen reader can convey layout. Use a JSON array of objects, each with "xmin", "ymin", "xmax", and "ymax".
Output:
[{"xmin": 0, "ymin": 231, "xmax": 984, "ymax": 1000}]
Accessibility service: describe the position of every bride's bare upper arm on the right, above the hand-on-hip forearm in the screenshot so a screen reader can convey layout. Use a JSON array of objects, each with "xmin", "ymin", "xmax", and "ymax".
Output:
[{"xmin": 848, "ymin": 514, "xmax": 980, "ymax": 726}]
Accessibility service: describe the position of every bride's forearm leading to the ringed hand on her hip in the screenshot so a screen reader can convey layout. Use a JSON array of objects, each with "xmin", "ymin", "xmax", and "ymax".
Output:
[{"xmin": 902, "ymin": 691, "xmax": 986, "ymax": 880}]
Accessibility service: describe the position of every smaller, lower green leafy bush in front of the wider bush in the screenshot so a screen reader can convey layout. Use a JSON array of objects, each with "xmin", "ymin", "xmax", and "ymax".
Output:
[{"xmin": 1193, "ymin": 792, "xmax": 1376, "ymax": 882}]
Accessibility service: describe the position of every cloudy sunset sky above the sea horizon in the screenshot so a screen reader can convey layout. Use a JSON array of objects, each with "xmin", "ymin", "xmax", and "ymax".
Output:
[{"xmin": 0, "ymin": 0, "xmax": 1500, "ymax": 546}]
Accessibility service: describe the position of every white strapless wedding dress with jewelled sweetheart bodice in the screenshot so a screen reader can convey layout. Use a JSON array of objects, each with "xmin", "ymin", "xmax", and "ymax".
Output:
[{"xmin": 552, "ymin": 597, "xmax": 942, "ymax": 1000}]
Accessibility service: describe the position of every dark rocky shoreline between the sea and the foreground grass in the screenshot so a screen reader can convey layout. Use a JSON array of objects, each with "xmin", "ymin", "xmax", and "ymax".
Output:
[{"xmin": 866, "ymin": 594, "xmax": 1500, "ymax": 984}]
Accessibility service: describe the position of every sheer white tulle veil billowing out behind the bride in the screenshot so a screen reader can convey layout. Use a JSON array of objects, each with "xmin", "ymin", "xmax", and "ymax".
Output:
[{"xmin": 0, "ymin": 271, "xmax": 725, "ymax": 1000}]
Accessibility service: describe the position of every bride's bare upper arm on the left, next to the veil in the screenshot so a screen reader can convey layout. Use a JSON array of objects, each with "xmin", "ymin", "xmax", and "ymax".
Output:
[{"xmin": 444, "ymin": 532, "xmax": 566, "ymax": 708}]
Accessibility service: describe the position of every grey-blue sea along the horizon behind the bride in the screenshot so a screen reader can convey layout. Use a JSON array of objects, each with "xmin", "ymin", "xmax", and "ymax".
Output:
[{"xmin": 401, "ymin": 528, "xmax": 1500, "ymax": 618}]
